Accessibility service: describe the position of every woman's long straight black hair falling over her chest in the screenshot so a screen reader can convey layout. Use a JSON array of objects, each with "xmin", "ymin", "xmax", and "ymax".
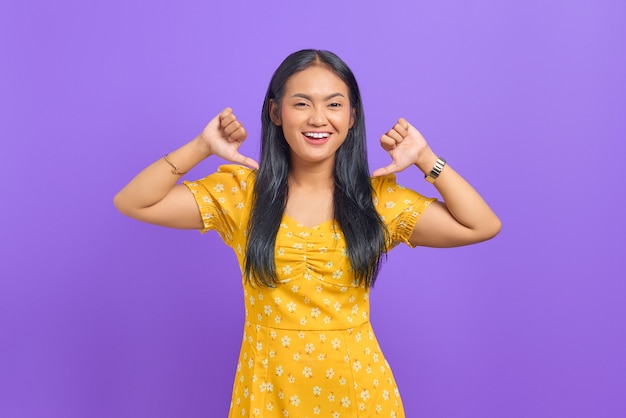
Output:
[{"xmin": 244, "ymin": 49, "xmax": 387, "ymax": 287}]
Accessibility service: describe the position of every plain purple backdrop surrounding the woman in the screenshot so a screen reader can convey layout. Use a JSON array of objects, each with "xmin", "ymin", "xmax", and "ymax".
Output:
[{"xmin": 0, "ymin": 0, "xmax": 626, "ymax": 418}]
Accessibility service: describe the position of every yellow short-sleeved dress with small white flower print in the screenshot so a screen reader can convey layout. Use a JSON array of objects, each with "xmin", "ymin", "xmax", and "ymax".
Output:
[{"xmin": 185, "ymin": 165, "xmax": 434, "ymax": 418}]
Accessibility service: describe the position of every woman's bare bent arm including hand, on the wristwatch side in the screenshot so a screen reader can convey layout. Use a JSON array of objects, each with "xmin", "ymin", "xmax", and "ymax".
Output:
[{"xmin": 373, "ymin": 119, "xmax": 501, "ymax": 247}]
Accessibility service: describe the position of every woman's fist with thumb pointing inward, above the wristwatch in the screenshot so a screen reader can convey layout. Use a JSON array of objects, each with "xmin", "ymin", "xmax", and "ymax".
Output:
[{"xmin": 372, "ymin": 118, "xmax": 437, "ymax": 177}]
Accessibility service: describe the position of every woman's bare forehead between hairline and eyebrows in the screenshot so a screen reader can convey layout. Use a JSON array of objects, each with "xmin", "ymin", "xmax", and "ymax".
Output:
[{"xmin": 285, "ymin": 65, "xmax": 348, "ymax": 97}]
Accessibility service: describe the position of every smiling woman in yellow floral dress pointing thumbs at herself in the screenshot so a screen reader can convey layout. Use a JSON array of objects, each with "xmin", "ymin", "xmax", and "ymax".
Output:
[{"xmin": 115, "ymin": 50, "xmax": 500, "ymax": 417}]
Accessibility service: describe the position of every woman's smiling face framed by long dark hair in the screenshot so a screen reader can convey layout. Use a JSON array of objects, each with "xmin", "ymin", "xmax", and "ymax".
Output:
[{"xmin": 270, "ymin": 65, "xmax": 354, "ymax": 169}]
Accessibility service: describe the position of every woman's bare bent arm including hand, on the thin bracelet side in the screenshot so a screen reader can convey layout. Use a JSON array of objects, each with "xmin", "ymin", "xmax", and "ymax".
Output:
[{"xmin": 113, "ymin": 108, "xmax": 258, "ymax": 229}]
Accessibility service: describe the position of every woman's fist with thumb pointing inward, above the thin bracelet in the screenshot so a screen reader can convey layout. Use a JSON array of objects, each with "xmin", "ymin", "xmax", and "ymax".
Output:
[{"xmin": 199, "ymin": 107, "xmax": 259, "ymax": 169}]
